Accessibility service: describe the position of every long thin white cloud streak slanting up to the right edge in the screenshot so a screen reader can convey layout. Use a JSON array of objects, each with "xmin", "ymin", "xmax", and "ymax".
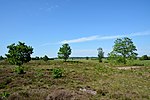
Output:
[{"xmin": 60, "ymin": 31, "xmax": 150, "ymax": 44}]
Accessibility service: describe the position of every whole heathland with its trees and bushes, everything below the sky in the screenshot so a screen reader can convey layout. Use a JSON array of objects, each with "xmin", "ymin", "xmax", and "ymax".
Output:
[{"xmin": 0, "ymin": 37, "xmax": 150, "ymax": 100}]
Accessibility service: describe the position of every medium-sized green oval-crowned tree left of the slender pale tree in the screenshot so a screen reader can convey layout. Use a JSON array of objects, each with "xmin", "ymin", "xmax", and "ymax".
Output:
[{"xmin": 58, "ymin": 43, "xmax": 71, "ymax": 62}]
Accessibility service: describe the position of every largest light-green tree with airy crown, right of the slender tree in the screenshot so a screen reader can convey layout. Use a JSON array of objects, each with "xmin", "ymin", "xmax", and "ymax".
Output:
[{"xmin": 109, "ymin": 37, "xmax": 137, "ymax": 64}]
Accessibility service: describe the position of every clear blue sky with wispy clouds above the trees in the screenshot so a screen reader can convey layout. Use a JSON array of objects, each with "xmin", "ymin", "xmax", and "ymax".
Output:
[{"xmin": 0, "ymin": 0, "xmax": 150, "ymax": 57}]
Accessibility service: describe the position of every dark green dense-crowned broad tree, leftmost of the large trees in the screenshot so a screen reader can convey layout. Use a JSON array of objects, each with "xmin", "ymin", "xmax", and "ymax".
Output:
[{"xmin": 6, "ymin": 42, "xmax": 33, "ymax": 66}]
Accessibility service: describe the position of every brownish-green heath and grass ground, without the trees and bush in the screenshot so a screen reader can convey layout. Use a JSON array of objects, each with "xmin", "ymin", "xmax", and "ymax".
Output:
[{"xmin": 0, "ymin": 60, "xmax": 150, "ymax": 100}]
